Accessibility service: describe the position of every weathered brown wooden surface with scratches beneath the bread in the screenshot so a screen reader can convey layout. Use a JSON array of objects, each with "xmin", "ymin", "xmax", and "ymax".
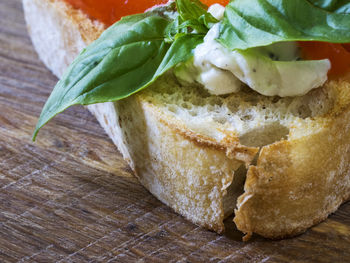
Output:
[{"xmin": 0, "ymin": 0, "xmax": 350, "ymax": 262}]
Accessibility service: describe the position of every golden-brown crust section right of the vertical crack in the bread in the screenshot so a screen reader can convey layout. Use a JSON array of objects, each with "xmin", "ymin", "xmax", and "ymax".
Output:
[{"xmin": 234, "ymin": 81, "xmax": 350, "ymax": 238}]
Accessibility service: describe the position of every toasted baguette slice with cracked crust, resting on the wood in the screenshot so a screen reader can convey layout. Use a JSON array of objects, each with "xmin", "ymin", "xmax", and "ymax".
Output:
[{"xmin": 23, "ymin": 0, "xmax": 350, "ymax": 238}]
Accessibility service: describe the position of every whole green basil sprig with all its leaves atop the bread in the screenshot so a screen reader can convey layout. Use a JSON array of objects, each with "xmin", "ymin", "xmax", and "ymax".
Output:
[{"xmin": 33, "ymin": 0, "xmax": 350, "ymax": 140}]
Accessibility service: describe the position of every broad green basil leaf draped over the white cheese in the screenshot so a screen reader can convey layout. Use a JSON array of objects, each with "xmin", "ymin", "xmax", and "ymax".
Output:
[{"xmin": 218, "ymin": 0, "xmax": 350, "ymax": 50}]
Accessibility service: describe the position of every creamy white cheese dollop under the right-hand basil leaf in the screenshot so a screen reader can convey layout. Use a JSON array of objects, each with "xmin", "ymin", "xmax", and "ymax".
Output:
[{"xmin": 191, "ymin": 23, "xmax": 330, "ymax": 97}]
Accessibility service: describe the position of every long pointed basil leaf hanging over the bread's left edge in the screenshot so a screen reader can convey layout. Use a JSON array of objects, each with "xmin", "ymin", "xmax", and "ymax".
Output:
[{"xmin": 33, "ymin": 13, "xmax": 203, "ymax": 140}]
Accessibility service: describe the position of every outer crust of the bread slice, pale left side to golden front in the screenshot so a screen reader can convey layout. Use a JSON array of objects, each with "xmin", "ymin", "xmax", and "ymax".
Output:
[{"xmin": 23, "ymin": 0, "xmax": 350, "ymax": 238}]
